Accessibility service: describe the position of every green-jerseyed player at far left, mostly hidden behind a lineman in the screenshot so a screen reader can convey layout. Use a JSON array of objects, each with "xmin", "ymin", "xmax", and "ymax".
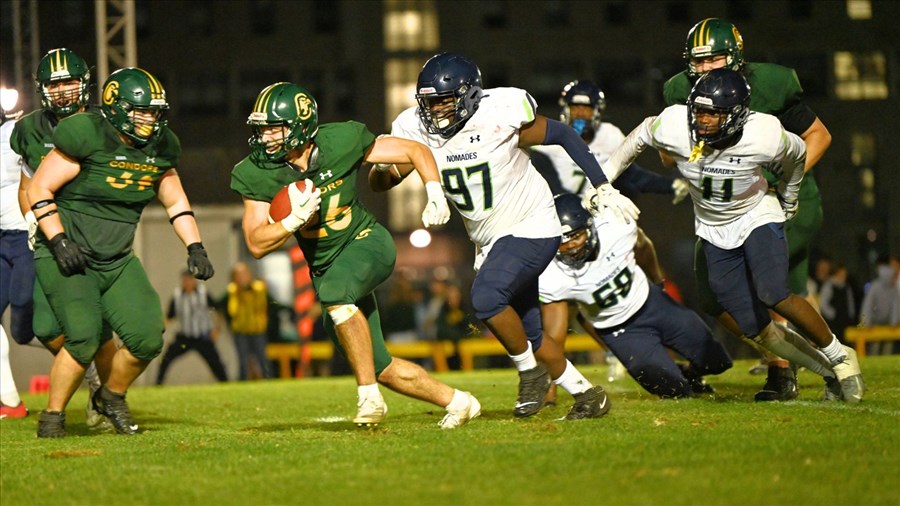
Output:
[{"xmin": 10, "ymin": 48, "xmax": 116, "ymax": 428}]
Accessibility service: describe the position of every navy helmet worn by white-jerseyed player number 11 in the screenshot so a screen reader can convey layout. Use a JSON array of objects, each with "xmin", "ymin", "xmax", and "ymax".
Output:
[{"xmin": 688, "ymin": 68, "xmax": 750, "ymax": 144}]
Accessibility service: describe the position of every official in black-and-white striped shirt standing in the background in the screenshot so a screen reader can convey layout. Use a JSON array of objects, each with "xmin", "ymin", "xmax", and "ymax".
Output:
[{"xmin": 156, "ymin": 271, "xmax": 228, "ymax": 385}]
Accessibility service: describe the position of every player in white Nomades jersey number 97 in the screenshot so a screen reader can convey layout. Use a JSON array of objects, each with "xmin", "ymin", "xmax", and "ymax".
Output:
[{"xmin": 370, "ymin": 53, "xmax": 638, "ymax": 419}]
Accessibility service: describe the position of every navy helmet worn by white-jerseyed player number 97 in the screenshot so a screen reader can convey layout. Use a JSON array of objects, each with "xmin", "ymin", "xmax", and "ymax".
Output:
[{"xmin": 416, "ymin": 53, "xmax": 482, "ymax": 139}]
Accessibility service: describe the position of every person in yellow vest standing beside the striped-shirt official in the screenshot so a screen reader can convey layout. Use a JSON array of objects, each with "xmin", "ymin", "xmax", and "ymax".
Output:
[{"xmin": 226, "ymin": 262, "xmax": 272, "ymax": 381}]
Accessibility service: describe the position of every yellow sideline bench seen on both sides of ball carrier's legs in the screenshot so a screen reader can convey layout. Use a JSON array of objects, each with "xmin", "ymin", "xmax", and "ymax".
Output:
[{"xmin": 266, "ymin": 341, "xmax": 454, "ymax": 378}]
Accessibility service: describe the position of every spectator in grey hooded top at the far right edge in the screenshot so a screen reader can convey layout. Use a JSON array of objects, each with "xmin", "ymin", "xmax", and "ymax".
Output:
[{"xmin": 859, "ymin": 255, "xmax": 900, "ymax": 355}]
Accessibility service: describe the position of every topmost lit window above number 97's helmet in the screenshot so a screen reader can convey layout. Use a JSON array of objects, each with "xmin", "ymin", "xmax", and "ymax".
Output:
[{"xmin": 384, "ymin": 0, "xmax": 440, "ymax": 52}]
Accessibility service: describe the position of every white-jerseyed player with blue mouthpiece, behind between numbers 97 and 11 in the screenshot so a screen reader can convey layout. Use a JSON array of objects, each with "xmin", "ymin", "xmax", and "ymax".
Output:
[{"xmin": 531, "ymin": 79, "xmax": 688, "ymax": 204}]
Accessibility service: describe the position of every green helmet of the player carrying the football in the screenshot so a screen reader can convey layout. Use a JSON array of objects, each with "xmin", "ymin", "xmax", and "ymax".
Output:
[{"xmin": 247, "ymin": 83, "xmax": 319, "ymax": 163}]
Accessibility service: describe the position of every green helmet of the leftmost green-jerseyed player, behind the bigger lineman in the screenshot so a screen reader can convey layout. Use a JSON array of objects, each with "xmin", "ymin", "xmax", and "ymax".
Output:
[{"xmin": 34, "ymin": 47, "xmax": 91, "ymax": 116}]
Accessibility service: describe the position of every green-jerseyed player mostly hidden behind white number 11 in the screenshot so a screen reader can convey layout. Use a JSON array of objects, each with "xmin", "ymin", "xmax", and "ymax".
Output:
[{"xmin": 663, "ymin": 18, "xmax": 831, "ymax": 401}]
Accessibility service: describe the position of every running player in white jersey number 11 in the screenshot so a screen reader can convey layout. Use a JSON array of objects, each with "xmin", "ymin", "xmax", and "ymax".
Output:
[{"xmin": 604, "ymin": 68, "xmax": 865, "ymax": 402}]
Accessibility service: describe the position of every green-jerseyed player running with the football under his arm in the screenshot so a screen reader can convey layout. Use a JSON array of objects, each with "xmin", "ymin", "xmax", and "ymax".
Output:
[{"xmin": 231, "ymin": 82, "xmax": 481, "ymax": 429}]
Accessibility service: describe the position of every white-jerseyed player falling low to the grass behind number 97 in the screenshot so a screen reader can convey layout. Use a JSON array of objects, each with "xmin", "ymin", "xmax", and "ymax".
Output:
[{"xmin": 539, "ymin": 193, "xmax": 731, "ymax": 398}]
